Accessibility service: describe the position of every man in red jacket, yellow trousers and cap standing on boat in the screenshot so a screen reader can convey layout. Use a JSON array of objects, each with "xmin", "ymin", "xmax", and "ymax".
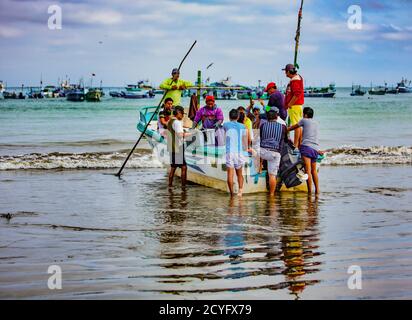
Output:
[{"xmin": 282, "ymin": 64, "xmax": 305, "ymax": 148}]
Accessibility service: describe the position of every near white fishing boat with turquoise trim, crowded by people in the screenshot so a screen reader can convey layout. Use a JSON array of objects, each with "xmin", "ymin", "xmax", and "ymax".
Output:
[{"xmin": 137, "ymin": 107, "xmax": 321, "ymax": 193}]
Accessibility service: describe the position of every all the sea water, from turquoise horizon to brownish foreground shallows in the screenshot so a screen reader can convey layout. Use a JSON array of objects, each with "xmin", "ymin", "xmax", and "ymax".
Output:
[{"xmin": 0, "ymin": 89, "xmax": 412, "ymax": 299}]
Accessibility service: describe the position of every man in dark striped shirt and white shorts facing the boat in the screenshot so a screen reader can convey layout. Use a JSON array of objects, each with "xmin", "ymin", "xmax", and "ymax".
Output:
[{"xmin": 260, "ymin": 107, "xmax": 287, "ymax": 196}]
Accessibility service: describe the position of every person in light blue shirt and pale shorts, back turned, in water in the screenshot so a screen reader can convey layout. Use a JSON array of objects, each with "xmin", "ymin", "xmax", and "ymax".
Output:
[{"xmin": 223, "ymin": 109, "xmax": 248, "ymax": 197}]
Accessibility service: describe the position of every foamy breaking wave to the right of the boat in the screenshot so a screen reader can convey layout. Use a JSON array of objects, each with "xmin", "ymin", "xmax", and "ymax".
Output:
[{"xmin": 322, "ymin": 146, "xmax": 412, "ymax": 166}]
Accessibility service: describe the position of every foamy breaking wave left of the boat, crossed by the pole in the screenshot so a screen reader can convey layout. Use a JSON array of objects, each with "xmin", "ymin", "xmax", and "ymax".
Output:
[{"xmin": 0, "ymin": 150, "xmax": 163, "ymax": 170}]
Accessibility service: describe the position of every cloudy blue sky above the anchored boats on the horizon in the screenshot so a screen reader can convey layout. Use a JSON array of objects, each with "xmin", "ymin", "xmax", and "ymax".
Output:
[{"xmin": 0, "ymin": 0, "xmax": 412, "ymax": 86}]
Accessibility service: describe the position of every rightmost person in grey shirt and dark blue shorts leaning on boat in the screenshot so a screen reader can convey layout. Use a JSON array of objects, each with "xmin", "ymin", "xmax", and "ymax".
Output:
[{"xmin": 288, "ymin": 107, "xmax": 323, "ymax": 194}]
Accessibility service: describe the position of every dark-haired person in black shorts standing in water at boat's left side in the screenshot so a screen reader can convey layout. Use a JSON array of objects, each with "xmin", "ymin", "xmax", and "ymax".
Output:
[{"xmin": 167, "ymin": 106, "xmax": 191, "ymax": 187}]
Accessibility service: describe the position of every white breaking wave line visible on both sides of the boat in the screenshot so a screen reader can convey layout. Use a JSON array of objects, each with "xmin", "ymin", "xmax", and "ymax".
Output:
[{"xmin": 0, "ymin": 146, "xmax": 412, "ymax": 170}]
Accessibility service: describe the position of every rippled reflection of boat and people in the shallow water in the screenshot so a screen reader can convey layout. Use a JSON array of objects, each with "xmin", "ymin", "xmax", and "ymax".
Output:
[{"xmin": 151, "ymin": 186, "xmax": 321, "ymax": 299}]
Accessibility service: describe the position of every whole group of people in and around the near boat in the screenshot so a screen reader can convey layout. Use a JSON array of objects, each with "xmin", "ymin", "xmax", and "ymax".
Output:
[{"xmin": 158, "ymin": 64, "xmax": 321, "ymax": 196}]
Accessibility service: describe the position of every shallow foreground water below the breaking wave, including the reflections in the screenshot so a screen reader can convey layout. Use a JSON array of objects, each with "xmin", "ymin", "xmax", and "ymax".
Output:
[{"xmin": 0, "ymin": 166, "xmax": 412, "ymax": 299}]
